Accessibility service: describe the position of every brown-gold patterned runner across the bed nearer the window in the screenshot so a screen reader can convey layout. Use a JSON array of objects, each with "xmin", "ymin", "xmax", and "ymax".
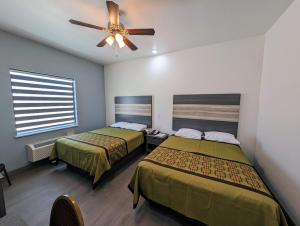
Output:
[{"xmin": 66, "ymin": 132, "xmax": 128, "ymax": 165}]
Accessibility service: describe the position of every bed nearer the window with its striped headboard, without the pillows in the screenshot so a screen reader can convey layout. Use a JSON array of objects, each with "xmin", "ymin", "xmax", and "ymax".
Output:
[{"xmin": 50, "ymin": 96, "xmax": 152, "ymax": 187}]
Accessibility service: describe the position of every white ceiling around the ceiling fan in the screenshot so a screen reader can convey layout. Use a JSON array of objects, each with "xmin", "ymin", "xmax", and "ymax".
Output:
[{"xmin": 0, "ymin": 0, "xmax": 292, "ymax": 64}]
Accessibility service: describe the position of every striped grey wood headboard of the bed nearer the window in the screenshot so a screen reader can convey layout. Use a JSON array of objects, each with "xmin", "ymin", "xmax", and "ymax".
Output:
[{"xmin": 115, "ymin": 96, "xmax": 152, "ymax": 128}]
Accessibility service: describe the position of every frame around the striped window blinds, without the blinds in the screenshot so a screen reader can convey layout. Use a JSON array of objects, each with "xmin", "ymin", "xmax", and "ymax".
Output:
[{"xmin": 9, "ymin": 68, "xmax": 79, "ymax": 138}]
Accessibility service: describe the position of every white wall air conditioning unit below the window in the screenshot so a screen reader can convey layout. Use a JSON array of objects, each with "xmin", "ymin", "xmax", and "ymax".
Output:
[{"xmin": 26, "ymin": 137, "xmax": 61, "ymax": 162}]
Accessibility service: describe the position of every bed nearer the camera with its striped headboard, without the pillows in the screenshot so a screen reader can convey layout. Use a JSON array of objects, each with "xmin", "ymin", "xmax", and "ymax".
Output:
[{"xmin": 129, "ymin": 94, "xmax": 287, "ymax": 226}]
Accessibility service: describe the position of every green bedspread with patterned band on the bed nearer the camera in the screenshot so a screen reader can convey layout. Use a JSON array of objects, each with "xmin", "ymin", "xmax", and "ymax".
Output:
[{"xmin": 129, "ymin": 136, "xmax": 287, "ymax": 226}]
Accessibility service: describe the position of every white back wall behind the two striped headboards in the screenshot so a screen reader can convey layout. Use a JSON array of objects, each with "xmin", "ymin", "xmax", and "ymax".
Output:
[{"xmin": 104, "ymin": 36, "xmax": 264, "ymax": 159}]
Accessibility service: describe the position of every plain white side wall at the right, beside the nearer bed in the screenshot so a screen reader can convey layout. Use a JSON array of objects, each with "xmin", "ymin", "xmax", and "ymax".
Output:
[{"xmin": 256, "ymin": 1, "xmax": 300, "ymax": 225}]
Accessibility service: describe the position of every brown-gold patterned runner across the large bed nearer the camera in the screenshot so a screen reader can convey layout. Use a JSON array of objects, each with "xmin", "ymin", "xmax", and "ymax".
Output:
[{"xmin": 142, "ymin": 146, "xmax": 273, "ymax": 199}]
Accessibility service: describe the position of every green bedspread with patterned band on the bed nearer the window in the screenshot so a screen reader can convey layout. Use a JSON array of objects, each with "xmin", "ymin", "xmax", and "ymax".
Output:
[{"xmin": 50, "ymin": 128, "xmax": 144, "ymax": 184}]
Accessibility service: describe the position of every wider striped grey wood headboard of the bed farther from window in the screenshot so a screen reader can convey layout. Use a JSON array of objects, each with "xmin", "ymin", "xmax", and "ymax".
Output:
[{"xmin": 173, "ymin": 94, "xmax": 241, "ymax": 136}]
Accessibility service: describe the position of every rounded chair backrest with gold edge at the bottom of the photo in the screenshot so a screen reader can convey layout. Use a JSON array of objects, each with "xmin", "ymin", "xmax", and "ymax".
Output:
[{"xmin": 50, "ymin": 195, "xmax": 84, "ymax": 226}]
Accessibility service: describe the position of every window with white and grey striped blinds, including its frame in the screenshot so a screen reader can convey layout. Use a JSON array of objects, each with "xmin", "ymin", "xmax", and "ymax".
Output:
[{"xmin": 10, "ymin": 70, "xmax": 78, "ymax": 137}]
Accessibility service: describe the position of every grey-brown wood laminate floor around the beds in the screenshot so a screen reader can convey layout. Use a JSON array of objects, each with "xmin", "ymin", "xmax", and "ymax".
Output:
[{"xmin": 4, "ymin": 156, "xmax": 205, "ymax": 226}]
